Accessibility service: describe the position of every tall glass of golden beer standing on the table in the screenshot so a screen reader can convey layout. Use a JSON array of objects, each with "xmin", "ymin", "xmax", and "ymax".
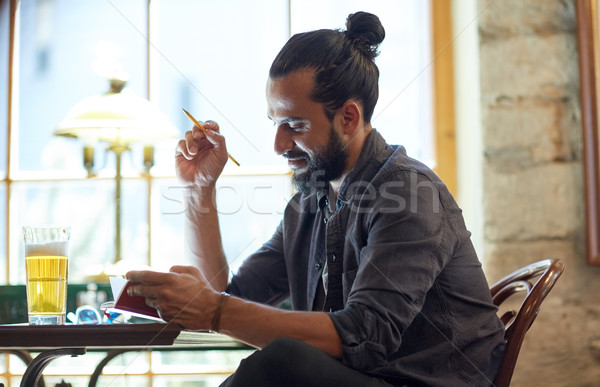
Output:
[{"xmin": 23, "ymin": 226, "xmax": 71, "ymax": 325}]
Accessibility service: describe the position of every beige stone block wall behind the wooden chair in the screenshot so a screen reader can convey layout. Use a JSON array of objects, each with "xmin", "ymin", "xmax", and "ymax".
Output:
[{"xmin": 478, "ymin": 0, "xmax": 600, "ymax": 386}]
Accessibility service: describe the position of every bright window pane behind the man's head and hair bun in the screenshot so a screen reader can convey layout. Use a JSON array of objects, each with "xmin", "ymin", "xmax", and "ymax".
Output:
[{"xmin": 291, "ymin": 0, "xmax": 433, "ymax": 165}]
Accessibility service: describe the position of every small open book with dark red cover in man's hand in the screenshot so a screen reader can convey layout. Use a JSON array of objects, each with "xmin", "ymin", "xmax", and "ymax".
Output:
[{"xmin": 100, "ymin": 277, "xmax": 164, "ymax": 322}]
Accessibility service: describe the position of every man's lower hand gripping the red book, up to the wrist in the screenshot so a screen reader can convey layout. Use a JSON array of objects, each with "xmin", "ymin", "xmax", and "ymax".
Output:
[{"xmin": 127, "ymin": 266, "xmax": 219, "ymax": 330}]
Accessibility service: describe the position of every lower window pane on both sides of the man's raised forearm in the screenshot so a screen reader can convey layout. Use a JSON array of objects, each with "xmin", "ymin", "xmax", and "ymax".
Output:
[{"xmin": 152, "ymin": 175, "xmax": 292, "ymax": 271}]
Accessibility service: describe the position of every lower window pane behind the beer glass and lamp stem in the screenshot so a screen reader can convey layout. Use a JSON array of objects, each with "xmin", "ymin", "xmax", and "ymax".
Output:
[{"xmin": 10, "ymin": 179, "xmax": 148, "ymax": 284}]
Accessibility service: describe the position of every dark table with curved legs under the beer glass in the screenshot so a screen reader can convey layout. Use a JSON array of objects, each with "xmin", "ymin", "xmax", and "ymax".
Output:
[{"xmin": 0, "ymin": 323, "xmax": 250, "ymax": 387}]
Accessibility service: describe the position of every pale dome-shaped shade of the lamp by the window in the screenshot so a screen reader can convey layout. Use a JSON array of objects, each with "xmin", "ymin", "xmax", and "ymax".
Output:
[{"xmin": 54, "ymin": 80, "xmax": 179, "ymax": 145}]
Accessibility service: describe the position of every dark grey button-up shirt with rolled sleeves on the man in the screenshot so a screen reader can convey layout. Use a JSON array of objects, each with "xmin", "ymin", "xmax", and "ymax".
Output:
[{"xmin": 229, "ymin": 130, "xmax": 504, "ymax": 386}]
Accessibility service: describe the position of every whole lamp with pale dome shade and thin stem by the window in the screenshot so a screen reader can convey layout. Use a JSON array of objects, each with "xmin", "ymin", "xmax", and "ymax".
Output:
[{"xmin": 54, "ymin": 78, "xmax": 178, "ymax": 280}]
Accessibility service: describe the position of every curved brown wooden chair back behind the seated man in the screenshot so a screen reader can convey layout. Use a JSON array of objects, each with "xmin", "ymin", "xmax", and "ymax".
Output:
[{"xmin": 490, "ymin": 259, "xmax": 564, "ymax": 387}]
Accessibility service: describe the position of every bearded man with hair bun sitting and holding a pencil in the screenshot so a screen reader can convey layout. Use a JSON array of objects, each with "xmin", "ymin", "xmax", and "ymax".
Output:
[{"xmin": 128, "ymin": 12, "xmax": 504, "ymax": 386}]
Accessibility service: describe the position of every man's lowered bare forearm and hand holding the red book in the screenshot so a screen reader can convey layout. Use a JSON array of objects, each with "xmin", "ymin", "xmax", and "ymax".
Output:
[{"xmin": 127, "ymin": 266, "xmax": 342, "ymax": 357}]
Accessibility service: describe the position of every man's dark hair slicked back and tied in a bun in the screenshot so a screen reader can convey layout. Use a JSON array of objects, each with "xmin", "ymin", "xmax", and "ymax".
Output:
[{"xmin": 269, "ymin": 12, "xmax": 385, "ymax": 123}]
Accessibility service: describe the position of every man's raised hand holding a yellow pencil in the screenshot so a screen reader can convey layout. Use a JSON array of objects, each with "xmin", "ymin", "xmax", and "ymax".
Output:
[{"xmin": 175, "ymin": 121, "xmax": 227, "ymax": 187}]
